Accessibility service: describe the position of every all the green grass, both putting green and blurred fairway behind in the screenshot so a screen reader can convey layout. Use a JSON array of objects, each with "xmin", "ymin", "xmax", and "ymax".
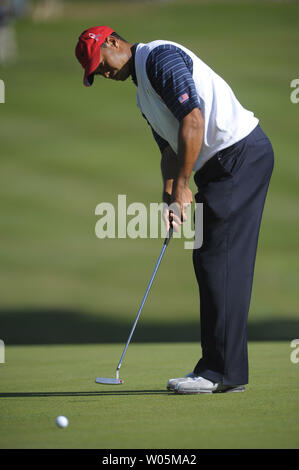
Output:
[{"xmin": 0, "ymin": 0, "xmax": 299, "ymax": 448}]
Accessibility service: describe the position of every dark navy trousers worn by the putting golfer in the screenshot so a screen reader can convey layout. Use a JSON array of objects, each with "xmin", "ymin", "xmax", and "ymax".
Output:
[{"xmin": 193, "ymin": 125, "xmax": 274, "ymax": 385}]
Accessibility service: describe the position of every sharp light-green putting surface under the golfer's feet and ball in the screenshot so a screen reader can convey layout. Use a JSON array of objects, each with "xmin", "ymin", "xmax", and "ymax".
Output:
[{"xmin": 0, "ymin": 342, "xmax": 299, "ymax": 449}]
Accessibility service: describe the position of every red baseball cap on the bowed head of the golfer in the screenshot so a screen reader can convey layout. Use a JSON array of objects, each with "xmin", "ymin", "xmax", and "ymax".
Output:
[{"xmin": 75, "ymin": 26, "xmax": 114, "ymax": 86}]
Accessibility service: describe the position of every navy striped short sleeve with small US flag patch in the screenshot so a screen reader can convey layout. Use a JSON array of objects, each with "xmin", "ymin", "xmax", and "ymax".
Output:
[{"xmin": 146, "ymin": 44, "xmax": 201, "ymax": 121}]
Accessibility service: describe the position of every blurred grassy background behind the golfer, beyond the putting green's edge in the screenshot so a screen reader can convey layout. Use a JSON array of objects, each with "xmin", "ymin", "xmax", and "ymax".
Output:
[{"xmin": 0, "ymin": 0, "xmax": 299, "ymax": 344}]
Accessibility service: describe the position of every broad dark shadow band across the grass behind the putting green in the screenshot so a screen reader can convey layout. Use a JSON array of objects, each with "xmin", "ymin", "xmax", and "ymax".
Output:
[{"xmin": 0, "ymin": 308, "xmax": 299, "ymax": 344}]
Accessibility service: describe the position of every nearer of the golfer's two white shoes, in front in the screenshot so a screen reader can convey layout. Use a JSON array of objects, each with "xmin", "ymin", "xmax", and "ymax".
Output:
[{"xmin": 174, "ymin": 376, "xmax": 245, "ymax": 395}]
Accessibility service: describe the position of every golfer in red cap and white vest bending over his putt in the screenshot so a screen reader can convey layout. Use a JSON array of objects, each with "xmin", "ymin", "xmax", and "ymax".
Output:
[{"xmin": 76, "ymin": 26, "xmax": 274, "ymax": 394}]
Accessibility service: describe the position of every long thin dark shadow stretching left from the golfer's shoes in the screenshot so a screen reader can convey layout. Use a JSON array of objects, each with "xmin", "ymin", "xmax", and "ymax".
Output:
[{"xmin": 0, "ymin": 390, "xmax": 173, "ymax": 398}]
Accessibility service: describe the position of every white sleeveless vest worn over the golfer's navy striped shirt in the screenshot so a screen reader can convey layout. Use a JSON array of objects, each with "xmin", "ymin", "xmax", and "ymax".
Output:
[{"xmin": 135, "ymin": 40, "xmax": 259, "ymax": 171}]
